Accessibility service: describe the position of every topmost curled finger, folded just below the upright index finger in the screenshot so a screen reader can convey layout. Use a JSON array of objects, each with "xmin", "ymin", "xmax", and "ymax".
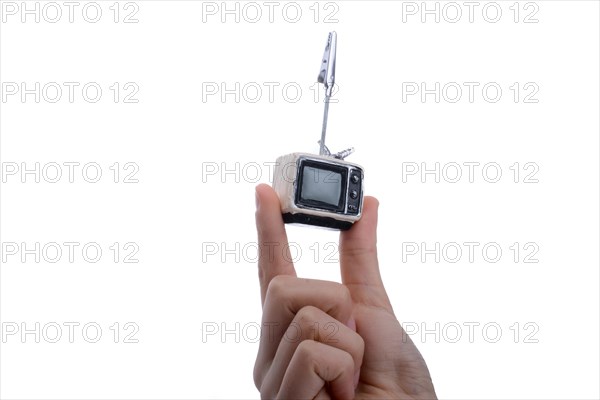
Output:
[{"xmin": 254, "ymin": 275, "xmax": 352, "ymax": 388}]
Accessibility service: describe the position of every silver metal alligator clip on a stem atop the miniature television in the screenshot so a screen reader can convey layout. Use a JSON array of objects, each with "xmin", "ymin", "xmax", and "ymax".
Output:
[{"xmin": 317, "ymin": 32, "xmax": 354, "ymax": 160}]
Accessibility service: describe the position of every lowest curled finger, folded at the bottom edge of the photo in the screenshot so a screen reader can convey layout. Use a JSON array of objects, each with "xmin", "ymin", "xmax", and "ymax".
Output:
[{"xmin": 277, "ymin": 340, "xmax": 354, "ymax": 399}]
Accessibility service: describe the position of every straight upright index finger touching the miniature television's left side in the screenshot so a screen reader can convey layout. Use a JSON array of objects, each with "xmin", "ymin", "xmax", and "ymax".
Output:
[{"xmin": 256, "ymin": 184, "xmax": 296, "ymax": 304}]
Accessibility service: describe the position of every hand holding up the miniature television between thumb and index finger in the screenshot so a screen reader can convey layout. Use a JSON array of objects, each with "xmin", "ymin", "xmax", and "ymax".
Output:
[{"xmin": 254, "ymin": 185, "xmax": 436, "ymax": 399}]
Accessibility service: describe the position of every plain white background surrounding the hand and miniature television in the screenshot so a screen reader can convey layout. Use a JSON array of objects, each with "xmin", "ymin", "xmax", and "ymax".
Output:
[{"xmin": 0, "ymin": 1, "xmax": 600, "ymax": 399}]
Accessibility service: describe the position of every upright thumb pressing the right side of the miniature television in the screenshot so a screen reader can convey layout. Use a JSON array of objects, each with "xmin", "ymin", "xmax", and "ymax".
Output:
[{"xmin": 340, "ymin": 197, "xmax": 389, "ymax": 306}]
